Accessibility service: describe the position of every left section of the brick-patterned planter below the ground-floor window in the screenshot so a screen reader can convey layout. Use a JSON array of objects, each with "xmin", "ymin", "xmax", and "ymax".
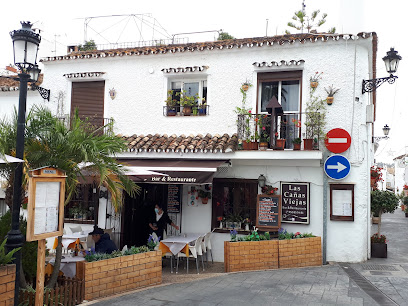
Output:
[{"xmin": 224, "ymin": 240, "xmax": 279, "ymax": 272}]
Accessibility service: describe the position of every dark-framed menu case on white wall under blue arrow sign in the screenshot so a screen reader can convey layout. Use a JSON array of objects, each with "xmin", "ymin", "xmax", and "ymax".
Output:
[{"xmin": 330, "ymin": 184, "xmax": 354, "ymax": 221}]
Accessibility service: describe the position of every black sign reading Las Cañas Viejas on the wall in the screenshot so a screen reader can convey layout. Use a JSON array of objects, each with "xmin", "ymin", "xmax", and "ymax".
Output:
[{"xmin": 281, "ymin": 182, "xmax": 310, "ymax": 224}]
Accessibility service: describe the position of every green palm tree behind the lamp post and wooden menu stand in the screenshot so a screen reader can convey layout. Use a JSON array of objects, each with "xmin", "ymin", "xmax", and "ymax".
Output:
[{"xmin": 0, "ymin": 107, "xmax": 139, "ymax": 287}]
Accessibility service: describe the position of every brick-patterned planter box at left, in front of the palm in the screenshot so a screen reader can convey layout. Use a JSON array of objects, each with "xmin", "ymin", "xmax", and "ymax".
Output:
[{"xmin": 77, "ymin": 251, "xmax": 162, "ymax": 301}]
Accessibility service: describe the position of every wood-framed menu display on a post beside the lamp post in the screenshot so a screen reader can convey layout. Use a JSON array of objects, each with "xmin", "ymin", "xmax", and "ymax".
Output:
[{"xmin": 27, "ymin": 167, "xmax": 66, "ymax": 241}]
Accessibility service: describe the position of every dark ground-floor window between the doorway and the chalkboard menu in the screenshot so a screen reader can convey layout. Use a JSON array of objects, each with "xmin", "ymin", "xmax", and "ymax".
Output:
[{"xmin": 212, "ymin": 179, "xmax": 258, "ymax": 228}]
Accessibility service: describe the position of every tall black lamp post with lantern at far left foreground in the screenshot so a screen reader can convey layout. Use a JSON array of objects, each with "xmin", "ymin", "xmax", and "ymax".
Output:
[{"xmin": 7, "ymin": 22, "xmax": 41, "ymax": 305}]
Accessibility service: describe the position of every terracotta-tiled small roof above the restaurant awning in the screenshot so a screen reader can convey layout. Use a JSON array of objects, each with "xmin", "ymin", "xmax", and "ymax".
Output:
[{"xmin": 119, "ymin": 134, "xmax": 238, "ymax": 153}]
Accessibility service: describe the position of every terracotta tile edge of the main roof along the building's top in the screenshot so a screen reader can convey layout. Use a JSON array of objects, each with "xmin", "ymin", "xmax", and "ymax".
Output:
[{"xmin": 41, "ymin": 32, "xmax": 376, "ymax": 62}]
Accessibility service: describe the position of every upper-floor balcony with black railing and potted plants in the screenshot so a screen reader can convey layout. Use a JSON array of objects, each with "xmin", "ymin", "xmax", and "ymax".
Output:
[{"xmin": 237, "ymin": 113, "xmax": 324, "ymax": 150}]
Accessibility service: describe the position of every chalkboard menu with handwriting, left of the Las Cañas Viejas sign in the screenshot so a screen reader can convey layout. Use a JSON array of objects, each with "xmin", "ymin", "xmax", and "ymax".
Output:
[{"xmin": 256, "ymin": 194, "xmax": 280, "ymax": 230}]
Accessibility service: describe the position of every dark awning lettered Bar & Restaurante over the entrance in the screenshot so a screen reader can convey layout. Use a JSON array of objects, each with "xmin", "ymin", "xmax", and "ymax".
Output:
[{"xmin": 118, "ymin": 159, "xmax": 227, "ymax": 184}]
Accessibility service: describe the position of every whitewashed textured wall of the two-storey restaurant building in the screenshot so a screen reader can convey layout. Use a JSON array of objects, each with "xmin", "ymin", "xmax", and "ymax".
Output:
[{"xmin": 39, "ymin": 34, "xmax": 373, "ymax": 262}]
